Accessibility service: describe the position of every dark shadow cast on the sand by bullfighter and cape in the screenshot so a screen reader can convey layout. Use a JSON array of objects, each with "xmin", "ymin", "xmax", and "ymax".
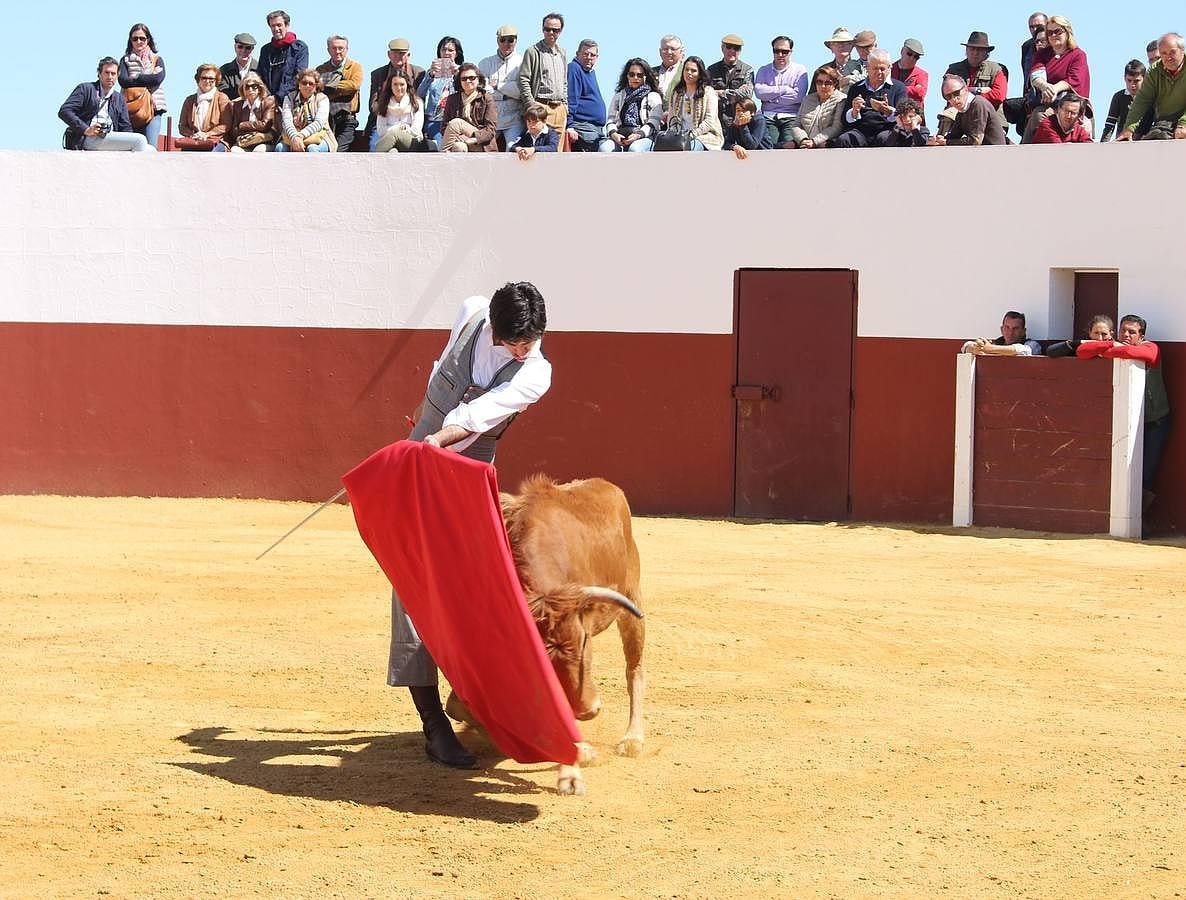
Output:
[{"xmin": 172, "ymin": 727, "xmax": 542, "ymax": 823}]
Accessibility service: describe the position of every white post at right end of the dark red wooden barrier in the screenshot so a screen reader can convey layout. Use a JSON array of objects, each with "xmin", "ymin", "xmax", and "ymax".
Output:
[{"xmin": 1108, "ymin": 359, "xmax": 1144, "ymax": 538}]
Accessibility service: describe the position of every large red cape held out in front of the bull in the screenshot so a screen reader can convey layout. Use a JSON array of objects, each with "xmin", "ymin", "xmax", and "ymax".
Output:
[{"xmin": 342, "ymin": 441, "xmax": 581, "ymax": 765}]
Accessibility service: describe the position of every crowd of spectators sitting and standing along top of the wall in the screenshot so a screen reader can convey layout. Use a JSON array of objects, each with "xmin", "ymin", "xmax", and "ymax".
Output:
[{"xmin": 58, "ymin": 9, "xmax": 1186, "ymax": 151}]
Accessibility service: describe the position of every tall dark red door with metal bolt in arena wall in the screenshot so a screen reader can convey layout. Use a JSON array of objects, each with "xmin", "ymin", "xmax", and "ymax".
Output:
[{"xmin": 733, "ymin": 269, "xmax": 856, "ymax": 522}]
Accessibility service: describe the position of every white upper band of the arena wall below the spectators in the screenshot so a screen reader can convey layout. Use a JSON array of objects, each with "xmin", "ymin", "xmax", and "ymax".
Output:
[{"xmin": 0, "ymin": 142, "xmax": 1186, "ymax": 340}]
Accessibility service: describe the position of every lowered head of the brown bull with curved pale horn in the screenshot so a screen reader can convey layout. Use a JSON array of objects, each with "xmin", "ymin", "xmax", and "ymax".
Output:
[{"xmin": 528, "ymin": 585, "xmax": 643, "ymax": 721}]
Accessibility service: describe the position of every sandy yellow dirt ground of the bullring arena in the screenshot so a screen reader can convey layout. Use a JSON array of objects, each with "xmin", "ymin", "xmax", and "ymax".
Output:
[{"xmin": 0, "ymin": 497, "xmax": 1186, "ymax": 898}]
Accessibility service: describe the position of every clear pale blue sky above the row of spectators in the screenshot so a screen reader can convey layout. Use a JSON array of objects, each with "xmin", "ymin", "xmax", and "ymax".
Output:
[{"xmin": 0, "ymin": 0, "xmax": 1186, "ymax": 149}]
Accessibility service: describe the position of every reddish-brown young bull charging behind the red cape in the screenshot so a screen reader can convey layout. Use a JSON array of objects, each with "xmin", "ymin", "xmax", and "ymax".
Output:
[{"xmin": 449, "ymin": 475, "xmax": 645, "ymax": 793}]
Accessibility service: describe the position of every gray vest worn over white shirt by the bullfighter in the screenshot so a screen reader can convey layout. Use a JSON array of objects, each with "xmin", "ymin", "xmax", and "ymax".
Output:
[{"xmin": 409, "ymin": 313, "xmax": 523, "ymax": 462}]
